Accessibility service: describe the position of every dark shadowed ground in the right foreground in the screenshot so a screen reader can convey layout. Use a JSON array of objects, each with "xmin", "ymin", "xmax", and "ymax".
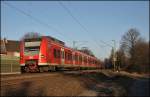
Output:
[{"xmin": 63, "ymin": 72, "xmax": 150, "ymax": 96}]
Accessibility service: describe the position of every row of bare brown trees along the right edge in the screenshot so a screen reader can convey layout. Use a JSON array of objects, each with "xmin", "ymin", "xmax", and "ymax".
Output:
[{"xmin": 104, "ymin": 28, "xmax": 150, "ymax": 73}]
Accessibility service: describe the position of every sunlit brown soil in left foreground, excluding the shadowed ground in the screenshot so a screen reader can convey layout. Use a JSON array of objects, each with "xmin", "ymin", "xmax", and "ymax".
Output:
[{"xmin": 1, "ymin": 74, "xmax": 84, "ymax": 96}]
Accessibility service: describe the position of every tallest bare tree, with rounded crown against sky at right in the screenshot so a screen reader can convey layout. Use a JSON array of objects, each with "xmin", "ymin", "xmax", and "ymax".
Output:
[{"xmin": 121, "ymin": 28, "xmax": 140, "ymax": 65}]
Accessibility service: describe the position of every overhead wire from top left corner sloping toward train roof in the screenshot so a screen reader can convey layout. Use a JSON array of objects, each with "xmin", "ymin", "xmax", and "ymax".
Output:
[{"xmin": 4, "ymin": 2, "xmax": 72, "ymax": 38}]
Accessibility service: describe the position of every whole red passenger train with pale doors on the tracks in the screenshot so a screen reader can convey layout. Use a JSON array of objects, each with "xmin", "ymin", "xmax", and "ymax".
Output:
[{"xmin": 20, "ymin": 36, "xmax": 101, "ymax": 72}]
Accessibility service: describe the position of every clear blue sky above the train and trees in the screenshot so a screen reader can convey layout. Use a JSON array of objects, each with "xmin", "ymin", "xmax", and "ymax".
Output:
[{"xmin": 1, "ymin": 1, "xmax": 149, "ymax": 59}]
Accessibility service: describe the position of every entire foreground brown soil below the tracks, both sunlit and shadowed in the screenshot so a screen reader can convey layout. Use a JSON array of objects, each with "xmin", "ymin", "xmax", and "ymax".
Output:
[{"xmin": 1, "ymin": 71, "xmax": 149, "ymax": 96}]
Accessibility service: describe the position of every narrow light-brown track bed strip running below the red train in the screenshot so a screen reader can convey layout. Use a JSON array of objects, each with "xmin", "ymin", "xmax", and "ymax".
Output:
[{"xmin": 1, "ymin": 70, "xmax": 148, "ymax": 81}]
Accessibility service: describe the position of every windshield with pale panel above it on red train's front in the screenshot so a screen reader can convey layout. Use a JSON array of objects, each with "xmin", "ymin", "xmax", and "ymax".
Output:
[{"xmin": 24, "ymin": 39, "xmax": 41, "ymax": 56}]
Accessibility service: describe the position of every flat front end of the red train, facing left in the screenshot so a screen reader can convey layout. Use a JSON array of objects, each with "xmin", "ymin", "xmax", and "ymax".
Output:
[{"xmin": 20, "ymin": 38, "xmax": 45, "ymax": 72}]
